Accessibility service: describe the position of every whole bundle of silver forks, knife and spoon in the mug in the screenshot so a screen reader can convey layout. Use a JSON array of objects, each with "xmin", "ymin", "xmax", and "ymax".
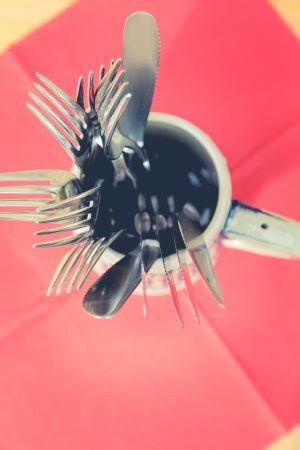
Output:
[{"xmin": 0, "ymin": 13, "xmax": 223, "ymax": 325}]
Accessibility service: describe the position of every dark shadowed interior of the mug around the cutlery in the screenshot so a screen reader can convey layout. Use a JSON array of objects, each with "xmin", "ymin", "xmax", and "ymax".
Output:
[{"xmin": 99, "ymin": 118, "xmax": 219, "ymax": 254}]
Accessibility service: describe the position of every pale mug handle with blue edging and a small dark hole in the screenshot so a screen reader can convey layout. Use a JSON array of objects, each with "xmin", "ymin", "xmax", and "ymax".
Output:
[{"xmin": 221, "ymin": 200, "xmax": 300, "ymax": 259}]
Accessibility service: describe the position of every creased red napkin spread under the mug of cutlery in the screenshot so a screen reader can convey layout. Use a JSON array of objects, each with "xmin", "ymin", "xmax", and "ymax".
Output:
[{"xmin": 0, "ymin": 0, "xmax": 300, "ymax": 450}]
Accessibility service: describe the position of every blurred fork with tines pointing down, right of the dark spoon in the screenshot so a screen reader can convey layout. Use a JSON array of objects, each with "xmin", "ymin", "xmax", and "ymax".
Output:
[{"xmin": 136, "ymin": 142, "xmax": 224, "ymax": 327}]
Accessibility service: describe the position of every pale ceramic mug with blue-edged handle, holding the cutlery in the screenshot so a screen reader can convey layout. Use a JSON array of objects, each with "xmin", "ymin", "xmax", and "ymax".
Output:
[{"xmin": 95, "ymin": 113, "xmax": 300, "ymax": 296}]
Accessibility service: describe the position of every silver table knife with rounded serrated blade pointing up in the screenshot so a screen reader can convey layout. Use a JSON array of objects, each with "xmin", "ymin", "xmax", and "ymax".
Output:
[{"xmin": 110, "ymin": 12, "xmax": 160, "ymax": 159}]
